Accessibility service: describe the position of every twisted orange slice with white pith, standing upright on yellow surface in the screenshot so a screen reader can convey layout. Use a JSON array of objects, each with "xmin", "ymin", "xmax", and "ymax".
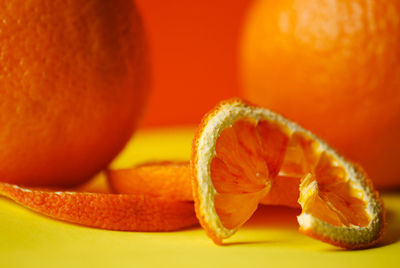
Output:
[{"xmin": 191, "ymin": 99, "xmax": 385, "ymax": 248}]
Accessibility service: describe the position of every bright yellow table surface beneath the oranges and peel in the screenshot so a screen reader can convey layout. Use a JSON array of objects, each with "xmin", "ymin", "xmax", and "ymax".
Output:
[{"xmin": 0, "ymin": 128, "xmax": 400, "ymax": 268}]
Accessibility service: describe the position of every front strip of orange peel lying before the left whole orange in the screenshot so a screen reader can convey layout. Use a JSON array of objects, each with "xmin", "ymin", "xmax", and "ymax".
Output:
[{"xmin": 0, "ymin": 183, "xmax": 198, "ymax": 231}]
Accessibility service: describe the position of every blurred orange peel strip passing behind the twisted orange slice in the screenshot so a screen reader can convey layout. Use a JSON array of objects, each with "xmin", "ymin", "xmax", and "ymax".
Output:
[{"xmin": 107, "ymin": 161, "xmax": 300, "ymax": 207}]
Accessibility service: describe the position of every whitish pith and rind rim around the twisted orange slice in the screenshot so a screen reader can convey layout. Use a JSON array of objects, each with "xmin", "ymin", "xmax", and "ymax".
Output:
[{"xmin": 193, "ymin": 101, "xmax": 383, "ymax": 245}]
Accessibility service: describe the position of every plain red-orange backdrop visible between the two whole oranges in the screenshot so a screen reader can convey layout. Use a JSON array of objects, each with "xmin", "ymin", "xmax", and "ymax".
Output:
[{"xmin": 136, "ymin": 0, "xmax": 251, "ymax": 127}]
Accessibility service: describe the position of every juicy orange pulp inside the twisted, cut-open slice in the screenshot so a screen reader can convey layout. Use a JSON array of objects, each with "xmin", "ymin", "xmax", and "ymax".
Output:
[{"xmin": 210, "ymin": 120, "xmax": 369, "ymax": 229}]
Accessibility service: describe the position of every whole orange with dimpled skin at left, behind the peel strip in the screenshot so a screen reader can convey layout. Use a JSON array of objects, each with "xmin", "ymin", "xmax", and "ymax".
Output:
[{"xmin": 0, "ymin": 0, "xmax": 148, "ymax": 185}]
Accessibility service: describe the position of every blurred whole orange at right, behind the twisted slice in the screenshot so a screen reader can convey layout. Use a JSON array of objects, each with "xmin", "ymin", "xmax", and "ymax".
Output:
[{"xmin": 241, "ymin": 0, "xmax": 400, "ymax": 188}]
